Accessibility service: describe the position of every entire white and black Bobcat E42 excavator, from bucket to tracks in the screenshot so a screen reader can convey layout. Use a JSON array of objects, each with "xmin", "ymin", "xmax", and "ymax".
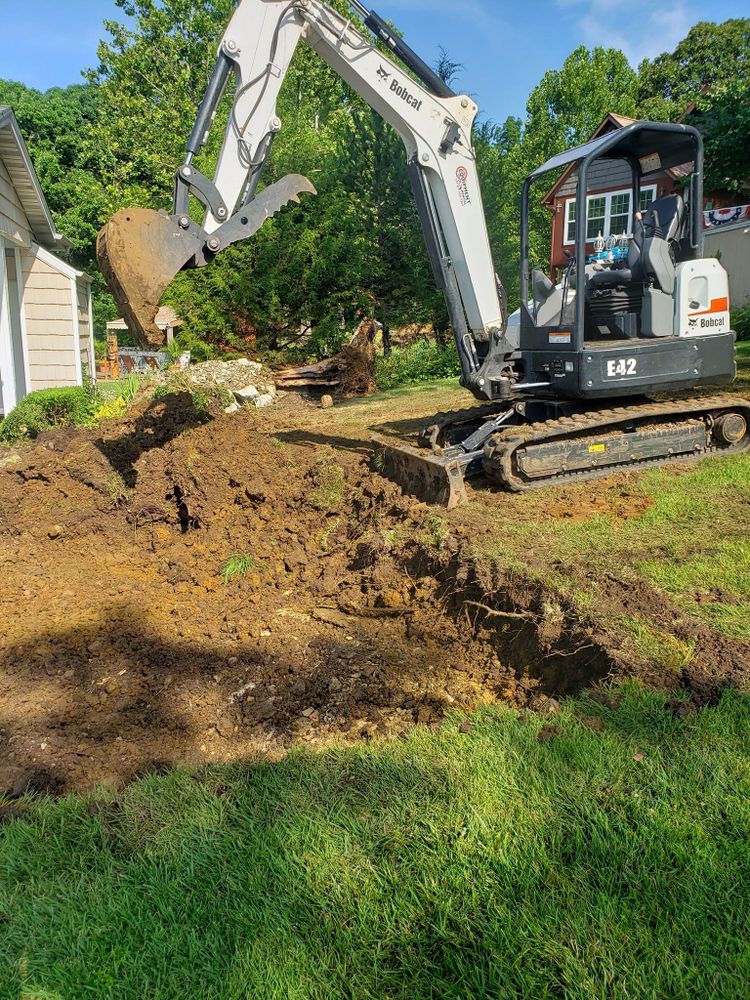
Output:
[{"xmin": 98, "ymin": 0, "xmax": 750, "ymax": 506}]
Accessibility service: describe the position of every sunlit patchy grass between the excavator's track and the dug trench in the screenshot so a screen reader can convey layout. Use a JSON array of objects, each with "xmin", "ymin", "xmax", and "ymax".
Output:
[{"xmin": 479, "ymin": 456, "xmax": 750, "ymax": 638}]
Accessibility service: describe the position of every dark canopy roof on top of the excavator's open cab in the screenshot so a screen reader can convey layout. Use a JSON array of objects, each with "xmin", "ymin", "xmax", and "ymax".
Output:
[{"xmin": 529, "ymin": 122, "xmax": 701, "ymax": 179}]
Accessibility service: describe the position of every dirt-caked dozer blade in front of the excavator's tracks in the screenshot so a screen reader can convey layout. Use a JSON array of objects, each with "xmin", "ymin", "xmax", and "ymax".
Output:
[{"xmin": 373, "ymin": 438, "xmax": 468, "ymax": 510}]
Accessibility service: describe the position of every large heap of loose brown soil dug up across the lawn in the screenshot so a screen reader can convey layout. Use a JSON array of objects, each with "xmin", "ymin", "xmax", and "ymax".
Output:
[{"xmin": 0, "ymin": 386, "xmax": 750, "ymax": 796}]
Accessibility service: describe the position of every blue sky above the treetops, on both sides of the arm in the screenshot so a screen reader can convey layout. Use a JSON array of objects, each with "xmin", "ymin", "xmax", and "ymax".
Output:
[{"xmin": 0, "ymin": 0, "xmax": 747, "ymax": 120}]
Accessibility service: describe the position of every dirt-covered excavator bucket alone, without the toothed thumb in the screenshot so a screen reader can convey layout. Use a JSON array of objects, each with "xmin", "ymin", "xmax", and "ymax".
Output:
[{"xmin": 96, "ymin": 208, "xmax": 201, "ymax": 350}]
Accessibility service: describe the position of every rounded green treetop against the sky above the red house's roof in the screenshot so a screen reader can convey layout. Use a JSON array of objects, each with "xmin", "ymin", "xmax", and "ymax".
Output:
[{"xmin": 638, "ymin": 18, "xmax": 750, "ymax": 121}]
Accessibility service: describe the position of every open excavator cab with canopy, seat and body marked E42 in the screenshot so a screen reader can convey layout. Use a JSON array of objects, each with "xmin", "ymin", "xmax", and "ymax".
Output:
[{"xmin": 519, "ymin": 122, "xmax": 736, "ymax": 399}]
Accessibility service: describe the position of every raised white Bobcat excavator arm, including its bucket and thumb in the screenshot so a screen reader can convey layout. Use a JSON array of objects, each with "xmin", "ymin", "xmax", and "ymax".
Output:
[{"xmin": 97, "ymin": 0, "xmax": 513, "ymax": 398}]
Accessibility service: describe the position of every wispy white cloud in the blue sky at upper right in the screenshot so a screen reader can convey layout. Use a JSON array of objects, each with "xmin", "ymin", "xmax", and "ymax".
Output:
[{"xmin": 557, "ymin": 0, "xmax": 699, "ymax": 66}]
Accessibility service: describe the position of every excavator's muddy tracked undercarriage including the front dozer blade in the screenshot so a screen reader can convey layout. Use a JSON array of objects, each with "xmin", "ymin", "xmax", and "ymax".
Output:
[{"xmin": 376, "ymin": 394, "xmax": 750, "ymax": 508}]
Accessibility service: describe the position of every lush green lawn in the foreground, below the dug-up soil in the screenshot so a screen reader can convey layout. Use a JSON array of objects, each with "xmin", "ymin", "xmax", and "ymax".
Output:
[{"xmin": 0, "ymin": 687, "xmax": 750, "ymax": 1000}]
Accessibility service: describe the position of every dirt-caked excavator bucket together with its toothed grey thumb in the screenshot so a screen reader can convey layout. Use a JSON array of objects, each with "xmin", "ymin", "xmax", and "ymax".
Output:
[{"xmin": 96, "ymin": 174, "xmax": 317, "ymax": 350}]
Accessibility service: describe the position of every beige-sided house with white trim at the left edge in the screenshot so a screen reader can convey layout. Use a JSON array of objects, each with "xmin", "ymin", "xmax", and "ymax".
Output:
[{"xmin": 0, "ymin": 107, "xmax": 94, "ymax": 415}]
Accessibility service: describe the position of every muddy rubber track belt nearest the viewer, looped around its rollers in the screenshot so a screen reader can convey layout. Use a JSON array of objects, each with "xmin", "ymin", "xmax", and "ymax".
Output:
[{"xmin": 484, "ymin": 393, "xmax": 750, "ymax": 493}]
